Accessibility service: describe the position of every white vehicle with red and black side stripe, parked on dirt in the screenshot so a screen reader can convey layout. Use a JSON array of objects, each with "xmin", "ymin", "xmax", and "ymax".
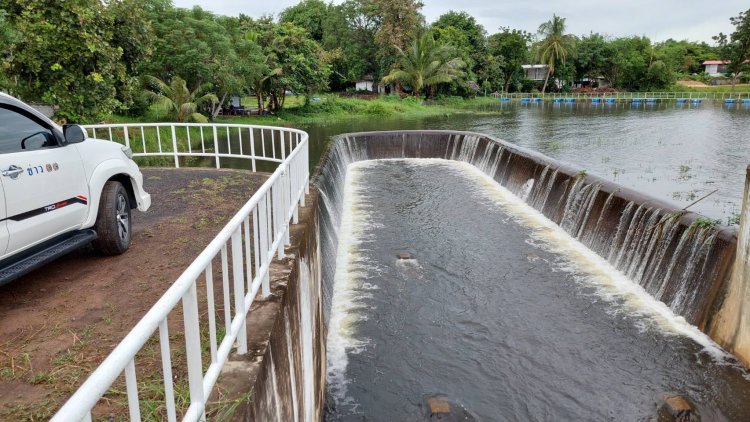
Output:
[{"xmin": 0, "ymin": 93, "xmax": 151, "ymax": 285}]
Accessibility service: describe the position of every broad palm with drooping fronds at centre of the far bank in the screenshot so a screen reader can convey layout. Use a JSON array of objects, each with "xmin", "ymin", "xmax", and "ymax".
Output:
[{"xmin": 383, "ymin": 33, "xmax": 466, "ymax": 96}]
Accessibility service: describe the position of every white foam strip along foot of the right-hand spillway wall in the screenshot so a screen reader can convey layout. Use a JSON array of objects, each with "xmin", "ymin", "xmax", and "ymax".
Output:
[{"xmin": 410, "ymin": 159, "xmax": 731, "ymax": 361}]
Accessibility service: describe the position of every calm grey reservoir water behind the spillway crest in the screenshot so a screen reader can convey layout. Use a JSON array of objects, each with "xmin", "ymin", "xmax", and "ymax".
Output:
[{"xmin": 305, "ymin": 102, "xmax": 750, "ymax": 224}]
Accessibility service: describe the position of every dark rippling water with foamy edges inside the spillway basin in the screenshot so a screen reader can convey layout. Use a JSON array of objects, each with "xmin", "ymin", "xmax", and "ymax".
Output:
[{"xmin": 327, "ymin": 160, "xmax": 750, "ymax": 421}]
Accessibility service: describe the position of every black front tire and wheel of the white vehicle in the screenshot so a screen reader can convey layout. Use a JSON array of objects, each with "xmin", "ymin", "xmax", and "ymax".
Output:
[{"xmin": 93, "ymin": 180, "xmax": 131, "ymax": 255}]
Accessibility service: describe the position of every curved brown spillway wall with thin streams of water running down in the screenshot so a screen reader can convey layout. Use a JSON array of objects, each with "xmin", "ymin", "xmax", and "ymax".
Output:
[{"xmin": 322, "ymin": 131, "xmax": 737, "ymax": 331}]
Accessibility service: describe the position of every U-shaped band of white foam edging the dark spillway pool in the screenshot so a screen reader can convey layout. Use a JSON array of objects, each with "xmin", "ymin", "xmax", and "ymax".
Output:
[{"xmin": 327, "ymin": 158, "xmax": 748, "ymax": 409}]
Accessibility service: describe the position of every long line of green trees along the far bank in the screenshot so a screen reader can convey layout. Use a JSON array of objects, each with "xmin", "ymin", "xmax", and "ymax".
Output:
[{"xmin": 0, "ymin": 0, "xmax": 750, "ymax": 121}]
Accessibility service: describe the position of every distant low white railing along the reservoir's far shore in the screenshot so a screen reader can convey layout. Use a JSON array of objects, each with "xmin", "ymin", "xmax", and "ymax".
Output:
[{"xmin": 496, "ymin": 92, "xmax": 750, "ymax": 100}]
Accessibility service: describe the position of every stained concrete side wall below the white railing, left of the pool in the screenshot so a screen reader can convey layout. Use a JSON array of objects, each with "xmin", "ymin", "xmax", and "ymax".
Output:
[{"xmin": 212, "ymin": 190, "xmax": 326, "ymax": 421}]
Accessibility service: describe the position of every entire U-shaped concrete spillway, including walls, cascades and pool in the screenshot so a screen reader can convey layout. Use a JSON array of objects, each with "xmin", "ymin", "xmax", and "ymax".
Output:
[{"xmin": 244, "ymin": 131, "xmax": 750, "ymax": 421}]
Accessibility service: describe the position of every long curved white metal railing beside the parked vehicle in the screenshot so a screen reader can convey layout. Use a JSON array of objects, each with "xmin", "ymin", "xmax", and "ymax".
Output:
[{"xmin": 52, "ymin": 124, "xmax": 309, "ymax": 421}]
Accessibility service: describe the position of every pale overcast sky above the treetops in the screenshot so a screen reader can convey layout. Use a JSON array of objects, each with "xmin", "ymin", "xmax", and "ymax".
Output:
[{"xmin": 173, "ymin": 0, "xmax": 750, "ymax": 45}]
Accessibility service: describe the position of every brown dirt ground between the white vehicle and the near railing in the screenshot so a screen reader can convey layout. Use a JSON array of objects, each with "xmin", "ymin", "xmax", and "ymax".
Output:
[{"xmin": 0, "ymin": 169, "xmax": 267, "ymax": 420}]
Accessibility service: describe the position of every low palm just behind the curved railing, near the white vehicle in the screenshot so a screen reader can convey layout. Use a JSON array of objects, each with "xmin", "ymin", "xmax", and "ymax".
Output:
[{"xmin": 144, "ymin": 76, "xmax": 219, "ymax": 123}]
